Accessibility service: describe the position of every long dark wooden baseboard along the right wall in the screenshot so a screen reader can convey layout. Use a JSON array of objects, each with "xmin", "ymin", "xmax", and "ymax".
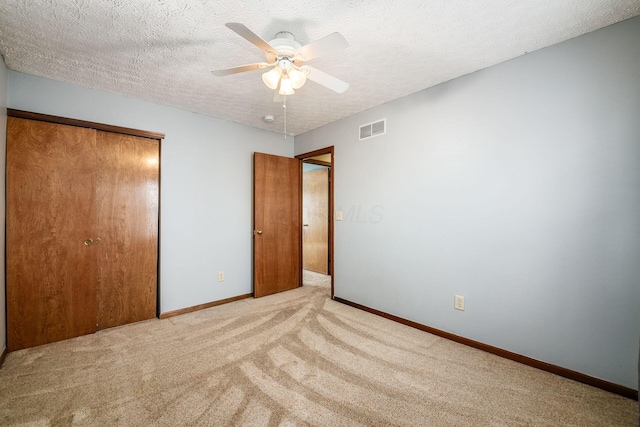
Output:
[{"xmin": 333, "ymin": 297, "xmax": 638, "ymax": 400}]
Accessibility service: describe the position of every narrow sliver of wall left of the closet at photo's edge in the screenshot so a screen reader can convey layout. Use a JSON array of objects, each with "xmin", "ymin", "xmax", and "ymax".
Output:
[{"xmin": 0, "ymin": 55, "xmax": 7, "ymax": 354}]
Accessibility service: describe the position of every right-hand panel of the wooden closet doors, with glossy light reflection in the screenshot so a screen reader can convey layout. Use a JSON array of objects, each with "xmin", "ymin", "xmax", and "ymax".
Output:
[{"xmin": 96, "ymin": 131, "xmax": 160, "ymax": 329}]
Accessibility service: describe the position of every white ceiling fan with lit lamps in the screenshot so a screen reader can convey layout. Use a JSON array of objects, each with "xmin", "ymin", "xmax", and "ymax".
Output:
[{"xmin": 211, "ymin": 22, "xmax": 349, "ymax": 95}]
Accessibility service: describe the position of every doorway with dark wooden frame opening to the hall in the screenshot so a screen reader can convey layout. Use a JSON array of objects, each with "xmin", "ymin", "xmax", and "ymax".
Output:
[{"xmin": 296, "ymin": 146, "xmax": 335, "ymax": 298}]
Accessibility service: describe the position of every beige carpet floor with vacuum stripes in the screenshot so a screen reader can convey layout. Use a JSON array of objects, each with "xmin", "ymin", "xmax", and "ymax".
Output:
[{"xmin": 0, "ymin": 273, "xmax": 638, "ymax": 426}]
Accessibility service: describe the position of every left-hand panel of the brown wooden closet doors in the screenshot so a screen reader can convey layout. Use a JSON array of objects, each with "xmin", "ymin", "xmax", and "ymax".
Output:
[{"xmin": 6, "ymin": 117, "xmax": 96, "ymax": 351}]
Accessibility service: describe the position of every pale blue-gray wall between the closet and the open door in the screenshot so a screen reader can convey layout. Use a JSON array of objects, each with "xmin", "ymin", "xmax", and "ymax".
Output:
[{"xmin": 8, "ymin": 71, "xmax": 294, "ymax": 312}]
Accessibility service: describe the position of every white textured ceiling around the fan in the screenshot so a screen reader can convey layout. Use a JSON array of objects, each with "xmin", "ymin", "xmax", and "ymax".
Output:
[{"xmin": 0, "ymin": 0, "xmax": 640, "ymax": 135}]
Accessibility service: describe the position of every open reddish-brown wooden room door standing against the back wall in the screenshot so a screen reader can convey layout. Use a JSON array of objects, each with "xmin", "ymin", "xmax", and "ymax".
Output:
[{"xmin": 253, "ymin": 153, "xmax": 301, "ymax": 298}]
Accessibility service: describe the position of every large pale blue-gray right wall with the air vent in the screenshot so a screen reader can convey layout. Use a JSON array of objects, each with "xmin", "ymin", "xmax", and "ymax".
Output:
[{"xmin": 295, "ymin": 18, "xmax": 640, "ymax": 389}]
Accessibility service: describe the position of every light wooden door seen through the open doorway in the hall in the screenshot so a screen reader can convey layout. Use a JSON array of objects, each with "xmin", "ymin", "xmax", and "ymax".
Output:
[{"xmin": 302, "ymin": 167, "xmax": 329, "ymax": 274}]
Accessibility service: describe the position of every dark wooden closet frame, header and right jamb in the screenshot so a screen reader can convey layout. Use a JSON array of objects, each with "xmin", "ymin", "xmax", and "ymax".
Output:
[{"xmin": 7, "ymin": 108, "xmax": 165, "ymax": 351}]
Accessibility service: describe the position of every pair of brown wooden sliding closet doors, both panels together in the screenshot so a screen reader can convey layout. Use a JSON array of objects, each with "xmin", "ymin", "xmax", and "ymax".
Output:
[{"xmin": 6, "ymin": 117, "xmax": 159, "ymax": 351}]
